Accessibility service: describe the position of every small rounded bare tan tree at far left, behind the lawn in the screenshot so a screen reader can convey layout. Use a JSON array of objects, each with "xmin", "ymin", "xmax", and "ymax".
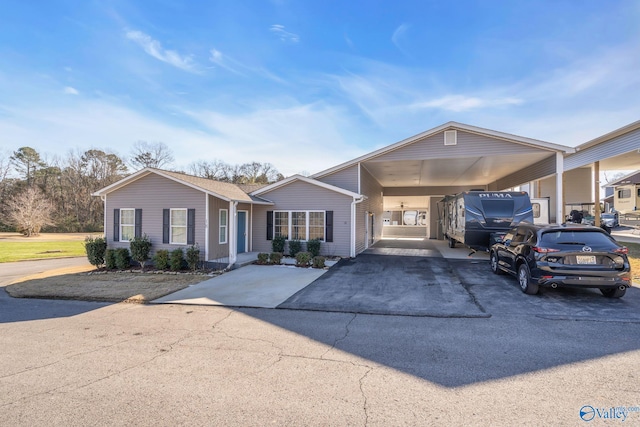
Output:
[{"xmin": 7, "ymin": 187, "xmax": 53, "ymax": 237}]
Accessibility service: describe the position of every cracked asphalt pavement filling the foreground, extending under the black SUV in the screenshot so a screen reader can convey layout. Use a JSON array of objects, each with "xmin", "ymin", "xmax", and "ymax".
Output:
[{"xmin": 0, "ymin": 260, "xmax": 640, "ymax": 426}]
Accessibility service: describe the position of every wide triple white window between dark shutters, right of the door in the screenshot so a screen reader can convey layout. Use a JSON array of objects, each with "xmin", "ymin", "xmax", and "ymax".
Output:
[{"xmin": 273, "ymin": 211, "xmax": 325, "ymax": 240}]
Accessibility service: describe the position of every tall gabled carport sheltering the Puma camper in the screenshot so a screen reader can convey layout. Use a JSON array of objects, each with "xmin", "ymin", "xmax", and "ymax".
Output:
[{"xmin": 313, "ymin": 122, "xmax": 574, "ymax": 253}]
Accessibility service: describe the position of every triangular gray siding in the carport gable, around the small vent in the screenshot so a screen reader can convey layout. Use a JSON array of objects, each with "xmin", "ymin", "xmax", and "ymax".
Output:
[{"xmin": 369, "ymin": 130, "xmax": 540, "ymax": 162}]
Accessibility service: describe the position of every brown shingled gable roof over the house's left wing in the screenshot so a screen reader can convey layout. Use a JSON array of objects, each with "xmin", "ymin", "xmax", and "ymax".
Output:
[{"xmin": 93, "ymin": 168, "xmax": 273, "ymax": 205}]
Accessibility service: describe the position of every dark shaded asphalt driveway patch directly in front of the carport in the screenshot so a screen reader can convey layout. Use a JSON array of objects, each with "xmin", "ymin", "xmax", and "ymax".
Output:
[{"xmin": 278, "ymin": 254, "xmax": 489, "ymax": 317}]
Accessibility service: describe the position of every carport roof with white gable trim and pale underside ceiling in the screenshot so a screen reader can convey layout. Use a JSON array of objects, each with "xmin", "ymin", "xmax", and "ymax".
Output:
[{"xmin": 312, "ymin": 122, "xmax": 575, "ymax": 187}]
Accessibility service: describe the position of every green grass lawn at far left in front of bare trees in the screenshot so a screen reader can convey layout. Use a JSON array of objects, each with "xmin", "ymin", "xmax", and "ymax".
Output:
[{"xmin": 0, "ymin": 240, "xmax": 86, "ymax": 262}]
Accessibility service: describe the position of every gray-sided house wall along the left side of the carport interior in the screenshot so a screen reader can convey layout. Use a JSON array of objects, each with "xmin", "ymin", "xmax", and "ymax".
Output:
[{"xmin": 356, "ymin": 167, "xmax": 382, "ymax": 254}]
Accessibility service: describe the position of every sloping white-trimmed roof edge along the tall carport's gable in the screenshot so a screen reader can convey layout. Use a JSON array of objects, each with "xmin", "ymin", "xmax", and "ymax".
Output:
[{"xmin": 311, "ymin": 122, "xmax": 575, "ymax": 178}]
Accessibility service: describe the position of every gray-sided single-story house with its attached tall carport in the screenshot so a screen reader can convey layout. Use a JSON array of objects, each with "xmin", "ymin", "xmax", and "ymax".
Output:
[{"xmin": 94, "ymin": 121, "xmax": 640, "ymax": 265}]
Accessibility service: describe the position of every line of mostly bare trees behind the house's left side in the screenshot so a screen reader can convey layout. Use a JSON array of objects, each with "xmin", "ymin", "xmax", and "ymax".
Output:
[{"xmin": 0, "ymin": 141, "xmax": 284, "ymax": 236}]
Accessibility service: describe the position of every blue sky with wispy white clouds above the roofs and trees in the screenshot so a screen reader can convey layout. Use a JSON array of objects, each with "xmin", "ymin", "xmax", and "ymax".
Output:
[{"xmin": 0, "ymin": 0, "xmax": 640, "ymax": 175}]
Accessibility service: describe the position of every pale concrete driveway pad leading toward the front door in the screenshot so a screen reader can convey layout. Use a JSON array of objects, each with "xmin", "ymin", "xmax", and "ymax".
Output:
[{"xmin": 151, "ymin": 265, "xmax": 327, "ymax": 308}]
